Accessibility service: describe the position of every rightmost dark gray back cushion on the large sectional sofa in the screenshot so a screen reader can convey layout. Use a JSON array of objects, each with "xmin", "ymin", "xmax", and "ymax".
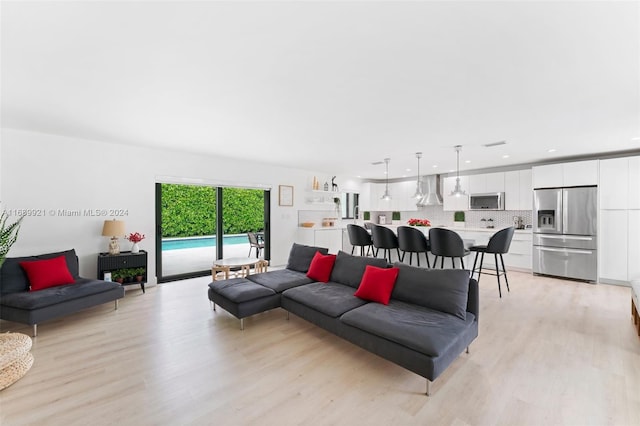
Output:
[{"xmin": 391, "ymin": 262, "xmax": 469, "ymax": 319}]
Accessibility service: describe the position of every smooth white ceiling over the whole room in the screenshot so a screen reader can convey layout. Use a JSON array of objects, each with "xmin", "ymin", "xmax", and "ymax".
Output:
[{"xmin": 1, "ymin": 1, "xmax": 640, "ymax": 178}]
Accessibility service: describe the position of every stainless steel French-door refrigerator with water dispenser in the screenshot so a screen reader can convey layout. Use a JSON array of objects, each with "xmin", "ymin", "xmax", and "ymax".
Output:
[{"xmin": 533, "ymin": 186, "xmax": 598, "ymax": 282}]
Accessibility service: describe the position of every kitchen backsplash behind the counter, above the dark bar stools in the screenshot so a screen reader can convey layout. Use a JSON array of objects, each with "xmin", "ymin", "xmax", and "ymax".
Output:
[{"xmin": 371, "ymin": 206, "xmax": 533, "ymax": 228}]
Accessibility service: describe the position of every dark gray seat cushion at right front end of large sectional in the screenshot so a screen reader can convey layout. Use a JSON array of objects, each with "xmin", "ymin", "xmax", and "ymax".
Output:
[{"xmin": 340, "ymin": 300, "xmax": 474, "ymax": 357}]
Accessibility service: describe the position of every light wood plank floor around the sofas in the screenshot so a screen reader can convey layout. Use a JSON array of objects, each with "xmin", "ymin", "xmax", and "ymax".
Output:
[{"xmin": 0, "ymin": 272, "xmax": 640, "ymax": 425}]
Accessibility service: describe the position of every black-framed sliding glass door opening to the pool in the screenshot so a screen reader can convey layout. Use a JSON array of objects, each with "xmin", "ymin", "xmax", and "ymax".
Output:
[{"xmin": 156, "ymin": 183, "xmax": 270, "ymax": 282}]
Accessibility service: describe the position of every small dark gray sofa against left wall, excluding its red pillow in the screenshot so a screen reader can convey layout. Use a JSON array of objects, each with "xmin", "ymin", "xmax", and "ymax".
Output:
[{"xmin": 0, "ymin": 249, "xmax": 124, "ymax": 337}]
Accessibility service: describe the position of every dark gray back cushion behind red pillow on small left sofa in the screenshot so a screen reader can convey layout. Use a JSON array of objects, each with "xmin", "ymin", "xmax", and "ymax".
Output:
[{"xmin": 0, "ymin": 249, "xmax": 80, "ymax": 294}]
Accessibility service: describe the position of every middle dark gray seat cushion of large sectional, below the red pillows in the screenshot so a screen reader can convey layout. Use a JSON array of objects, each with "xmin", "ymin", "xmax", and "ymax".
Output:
[{"xmin": 282, "ymin": 281, "xmax": 367, "ymax": 318}]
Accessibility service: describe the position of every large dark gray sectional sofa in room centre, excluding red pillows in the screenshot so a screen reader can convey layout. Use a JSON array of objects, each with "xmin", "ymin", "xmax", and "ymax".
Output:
[{"xmin": 209, "ymin": 244, "xmax": 479, "ymax": 395}]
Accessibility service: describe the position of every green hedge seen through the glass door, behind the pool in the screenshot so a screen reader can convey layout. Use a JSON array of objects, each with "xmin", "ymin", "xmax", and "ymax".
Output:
[{"xmin": 162, "ymin": 184, "xmax": 264, "ymax": 238}]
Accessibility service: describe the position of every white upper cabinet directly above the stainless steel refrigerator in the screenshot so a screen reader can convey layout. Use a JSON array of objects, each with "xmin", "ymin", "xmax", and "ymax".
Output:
[{"xmin": 533, "ymin": 160, "xmax": 598, "ymax": 188}]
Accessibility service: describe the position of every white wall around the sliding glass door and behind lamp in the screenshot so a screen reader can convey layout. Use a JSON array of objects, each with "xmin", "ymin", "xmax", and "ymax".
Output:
[{"xmin": 0, "ymin": 129, "xmax": 324, "ymax": 284}]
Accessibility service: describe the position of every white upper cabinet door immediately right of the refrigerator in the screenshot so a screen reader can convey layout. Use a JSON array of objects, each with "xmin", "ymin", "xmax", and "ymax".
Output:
[{"xmin": 598, "ymin": 158, "xmax": 630, "ymax": 209}]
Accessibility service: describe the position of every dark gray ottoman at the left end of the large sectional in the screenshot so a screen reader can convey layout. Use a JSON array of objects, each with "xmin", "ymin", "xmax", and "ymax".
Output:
[{"xmin": 209, "ymin": 278, "xmax": 280, "ymax": 330}]
